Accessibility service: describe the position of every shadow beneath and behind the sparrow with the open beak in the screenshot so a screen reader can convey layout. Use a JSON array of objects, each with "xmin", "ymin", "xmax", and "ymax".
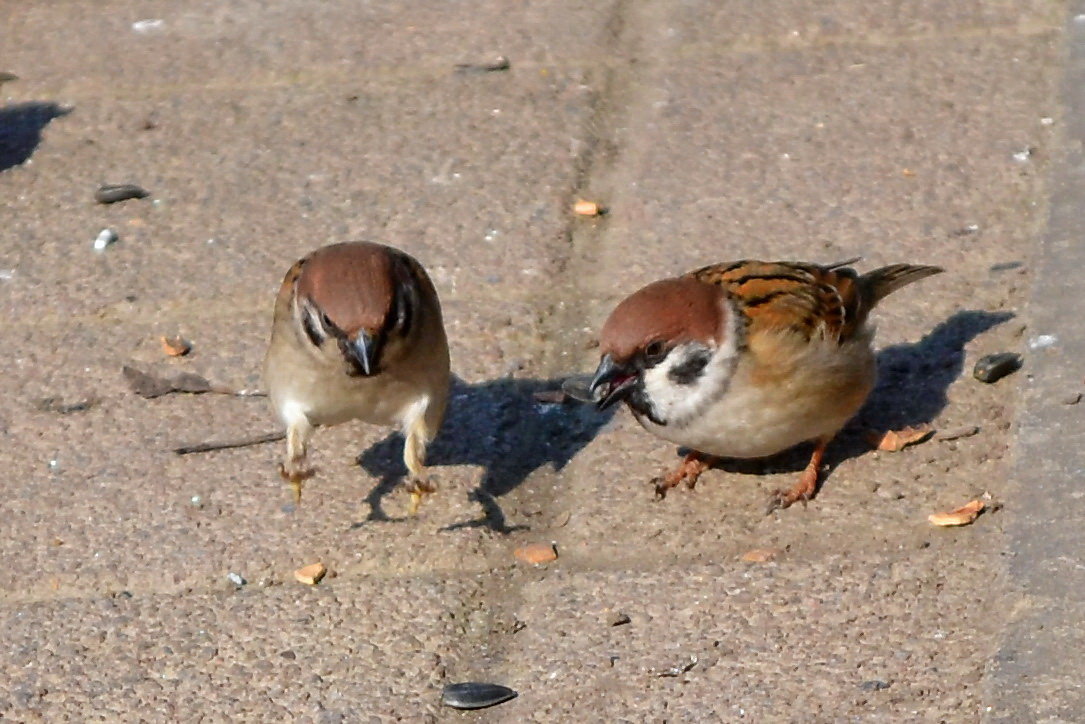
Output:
[{"xmin": 703, "ymin": 310, "xmax": 1013, "ymax": 478}]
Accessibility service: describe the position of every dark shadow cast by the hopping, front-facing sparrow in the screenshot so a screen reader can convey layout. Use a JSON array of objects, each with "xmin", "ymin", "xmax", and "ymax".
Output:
[{"xmin": 354, "ymin": 378, "xmax": 611, "ymax": 533}]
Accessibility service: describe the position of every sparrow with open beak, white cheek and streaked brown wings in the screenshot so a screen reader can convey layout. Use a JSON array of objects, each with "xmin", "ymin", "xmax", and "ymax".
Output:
[{"xmin": 587, "ymin": 258, "xmax": 942, "ymax": 510}]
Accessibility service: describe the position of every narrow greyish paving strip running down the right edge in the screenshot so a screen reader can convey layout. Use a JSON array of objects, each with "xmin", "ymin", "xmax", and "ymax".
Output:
[{"xmin": 988, "ymin": 2, "xmax": 1085, "ymax": 722}]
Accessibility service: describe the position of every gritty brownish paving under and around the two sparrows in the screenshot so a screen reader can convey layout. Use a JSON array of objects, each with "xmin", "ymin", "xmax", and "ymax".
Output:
[{"xmin": 0, "ymin": 0, "xmax": 1067, "ymax": 722}]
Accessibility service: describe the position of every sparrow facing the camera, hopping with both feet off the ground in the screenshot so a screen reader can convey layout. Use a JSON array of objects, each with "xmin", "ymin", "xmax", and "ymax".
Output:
[{"xmin": 264, "ymin": 242, "xmax": 449, "ymax": 513}]
